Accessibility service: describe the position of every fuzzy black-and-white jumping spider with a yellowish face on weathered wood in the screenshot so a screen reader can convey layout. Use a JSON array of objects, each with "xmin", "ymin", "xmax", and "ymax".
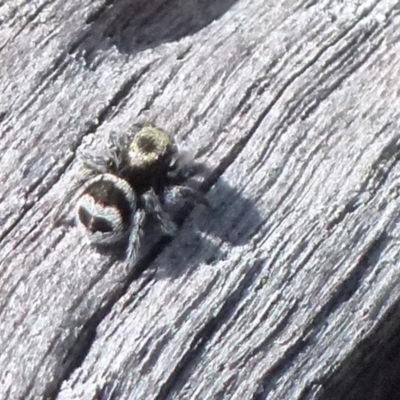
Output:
[{"xmin": 70, "ymin": 126, "xmax": 208, "ymax": 265}]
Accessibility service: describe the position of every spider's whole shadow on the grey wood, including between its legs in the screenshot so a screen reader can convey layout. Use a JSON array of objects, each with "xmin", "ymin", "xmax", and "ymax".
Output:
[{"xmin": 96, "ymin": 173, "xmax": 261, "ymax": 281}]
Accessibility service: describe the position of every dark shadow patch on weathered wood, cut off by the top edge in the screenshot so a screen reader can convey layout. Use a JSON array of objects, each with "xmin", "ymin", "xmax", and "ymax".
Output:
[{"xmin": 71, "ymin": 0, "xmax": 237, "ymax": 65}]
